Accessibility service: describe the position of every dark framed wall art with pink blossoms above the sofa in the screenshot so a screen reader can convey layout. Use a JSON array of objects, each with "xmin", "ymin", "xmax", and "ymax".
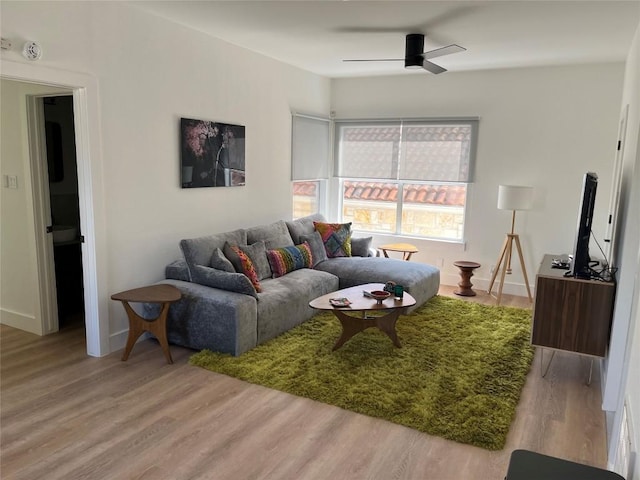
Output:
[{"xmin": 180, "ymin": 118, "xmax": 245, "ymax": 188}]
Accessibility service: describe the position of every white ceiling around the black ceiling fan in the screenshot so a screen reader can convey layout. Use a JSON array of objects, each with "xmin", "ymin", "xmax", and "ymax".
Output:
[{"xmin": 129, "ymin": 0, "xmax": 640, "ymax": 77}]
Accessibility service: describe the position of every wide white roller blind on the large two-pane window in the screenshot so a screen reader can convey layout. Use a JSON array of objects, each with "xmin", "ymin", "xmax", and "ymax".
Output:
[{"xmin": 336, "ymin": 119, "xmax": 478, "ymax": 183}]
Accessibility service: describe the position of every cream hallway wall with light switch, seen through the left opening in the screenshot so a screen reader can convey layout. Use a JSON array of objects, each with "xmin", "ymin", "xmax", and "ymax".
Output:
[{"xmin": 0, "ymin": 80, "xmax": 69, "ymax": 335}]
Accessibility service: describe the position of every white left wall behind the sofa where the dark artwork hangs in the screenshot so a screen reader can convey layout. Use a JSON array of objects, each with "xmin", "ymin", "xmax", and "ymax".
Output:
[{"xmin": 1, "ymin": 2, "xmax": 330, "ymax": 349}]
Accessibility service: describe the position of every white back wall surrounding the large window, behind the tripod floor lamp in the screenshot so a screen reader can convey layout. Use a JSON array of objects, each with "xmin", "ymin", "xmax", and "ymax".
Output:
[{"xmin": 331, "ymin": 63, "xmax": 624, "ymax": 295}]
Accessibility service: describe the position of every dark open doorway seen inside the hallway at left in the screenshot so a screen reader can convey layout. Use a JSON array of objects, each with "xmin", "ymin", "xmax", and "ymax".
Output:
[{"xmin": 39, "ymin": 95, "xmax": 84, "ymax": 329}]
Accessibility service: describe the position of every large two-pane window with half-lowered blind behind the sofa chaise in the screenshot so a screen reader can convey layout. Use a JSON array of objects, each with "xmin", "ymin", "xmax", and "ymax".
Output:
[{"xmin": 336, "ymin": 119, "xmax": 478, "ymax": 241}]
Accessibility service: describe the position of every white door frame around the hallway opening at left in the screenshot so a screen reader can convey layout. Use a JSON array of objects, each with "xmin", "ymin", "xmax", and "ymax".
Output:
[{"xmin": 1, "ymin": 60, "xmax": 110, "ymax": 357}]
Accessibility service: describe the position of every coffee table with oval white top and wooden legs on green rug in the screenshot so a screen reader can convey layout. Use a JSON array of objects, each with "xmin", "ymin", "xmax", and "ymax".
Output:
[{"xmin": 309, "ymin": 283, "xmax": 416, "ymax": 350}]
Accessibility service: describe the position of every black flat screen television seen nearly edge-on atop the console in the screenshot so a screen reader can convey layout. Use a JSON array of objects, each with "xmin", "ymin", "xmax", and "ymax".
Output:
[{"xmin": 572, "ymin": 172, "xmax": 598, "ymax": 278}]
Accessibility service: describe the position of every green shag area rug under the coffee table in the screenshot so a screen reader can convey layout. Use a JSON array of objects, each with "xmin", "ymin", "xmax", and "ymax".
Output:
[{"xmin": 190, "ymin": 296, "xmax": 533, "ymax": 450}]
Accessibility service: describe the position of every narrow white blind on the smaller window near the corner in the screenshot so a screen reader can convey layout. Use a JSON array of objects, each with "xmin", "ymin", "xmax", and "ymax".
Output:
[{"xmin": 291, "ymin": 113, "xmax": 331, "ymax": 181}]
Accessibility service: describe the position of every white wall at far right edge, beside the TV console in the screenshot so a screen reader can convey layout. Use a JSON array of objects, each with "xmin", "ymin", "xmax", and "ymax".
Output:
[{"xmin": 604, "ymin": 19, "xmax": 640, "ymax": 480}]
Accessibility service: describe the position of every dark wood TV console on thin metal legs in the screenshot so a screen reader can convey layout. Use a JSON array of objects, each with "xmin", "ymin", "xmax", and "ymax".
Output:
[{"xmin": 531, "ymin": 255, "xmax": 616, "ymax": 357}]
